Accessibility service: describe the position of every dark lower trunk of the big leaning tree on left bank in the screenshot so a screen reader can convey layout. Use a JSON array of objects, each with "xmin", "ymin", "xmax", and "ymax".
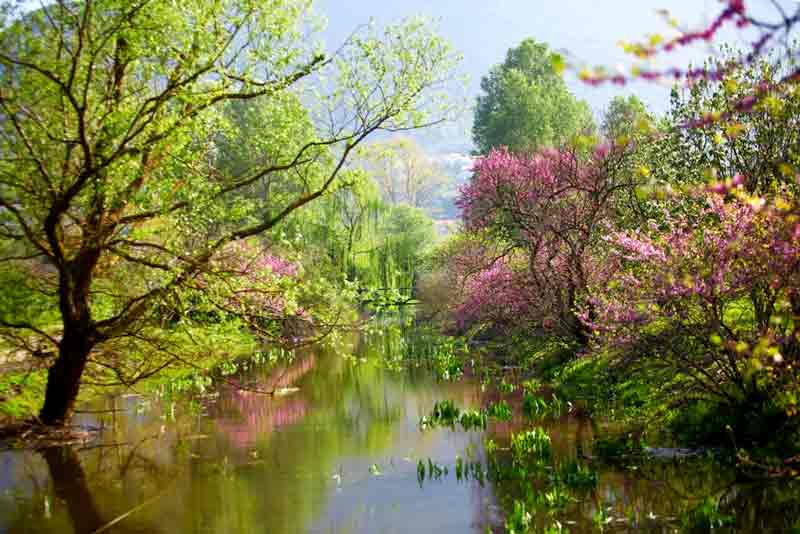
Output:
[{"xmin": 39, "ymin": 329, "xmax": 93, "ymax": 426}]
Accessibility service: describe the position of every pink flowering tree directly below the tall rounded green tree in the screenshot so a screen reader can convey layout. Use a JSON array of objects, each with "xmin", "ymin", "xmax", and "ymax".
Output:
[{"xmin": 458, "ymin": 146, "xmax": 635, "ymax": 342}]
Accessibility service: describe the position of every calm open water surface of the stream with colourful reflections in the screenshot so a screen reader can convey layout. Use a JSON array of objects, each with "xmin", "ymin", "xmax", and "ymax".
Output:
[{"xmin": 0, "ymin": 326, "xmax": 800, "ymax": 534}]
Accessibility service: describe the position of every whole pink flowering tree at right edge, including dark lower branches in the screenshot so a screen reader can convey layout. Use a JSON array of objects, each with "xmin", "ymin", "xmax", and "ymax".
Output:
[{"xmin": 582, "ymin": 191, "xmax": 800, "ymax": 416}]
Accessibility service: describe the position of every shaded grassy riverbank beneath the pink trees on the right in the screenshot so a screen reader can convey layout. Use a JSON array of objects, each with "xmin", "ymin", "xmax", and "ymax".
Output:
[{"xmin": 466, "ymin": 337, "xmax": 800, "ymax": 478}]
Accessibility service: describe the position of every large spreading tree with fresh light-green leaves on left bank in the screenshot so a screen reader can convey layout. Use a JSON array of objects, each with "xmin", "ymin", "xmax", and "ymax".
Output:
[{"xmin": 0, "ymin": 0, "xmax": 456, "ymax": 425}]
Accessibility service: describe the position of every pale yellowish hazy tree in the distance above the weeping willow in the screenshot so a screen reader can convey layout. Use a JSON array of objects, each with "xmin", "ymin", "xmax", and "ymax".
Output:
[{"xmin": 359, "ymin": 137, "xmax": 450, "ymax": 208}]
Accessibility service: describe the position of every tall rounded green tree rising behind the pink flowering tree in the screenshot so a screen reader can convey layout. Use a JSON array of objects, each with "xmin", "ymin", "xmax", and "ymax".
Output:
[{"xmin": 472, "ymin": 39, "xmax": 593, "ymax": 154}]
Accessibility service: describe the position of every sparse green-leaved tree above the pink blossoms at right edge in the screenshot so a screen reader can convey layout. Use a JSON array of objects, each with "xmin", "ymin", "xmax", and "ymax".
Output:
[{"xmin": 664, "ymin": 52, "xmax": 800, "ymax": 195}]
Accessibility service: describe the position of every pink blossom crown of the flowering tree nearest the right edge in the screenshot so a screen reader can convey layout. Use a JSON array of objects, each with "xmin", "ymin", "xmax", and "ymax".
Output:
[{"xmin": 581, "ymin": 194, "xmax": 800, "ymax": 354}]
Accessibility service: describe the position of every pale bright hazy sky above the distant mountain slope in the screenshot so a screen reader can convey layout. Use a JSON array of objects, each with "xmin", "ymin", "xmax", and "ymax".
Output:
[{"xmin": 316, "ymin": 0, "xmax": 767, "ymax": 117}]
